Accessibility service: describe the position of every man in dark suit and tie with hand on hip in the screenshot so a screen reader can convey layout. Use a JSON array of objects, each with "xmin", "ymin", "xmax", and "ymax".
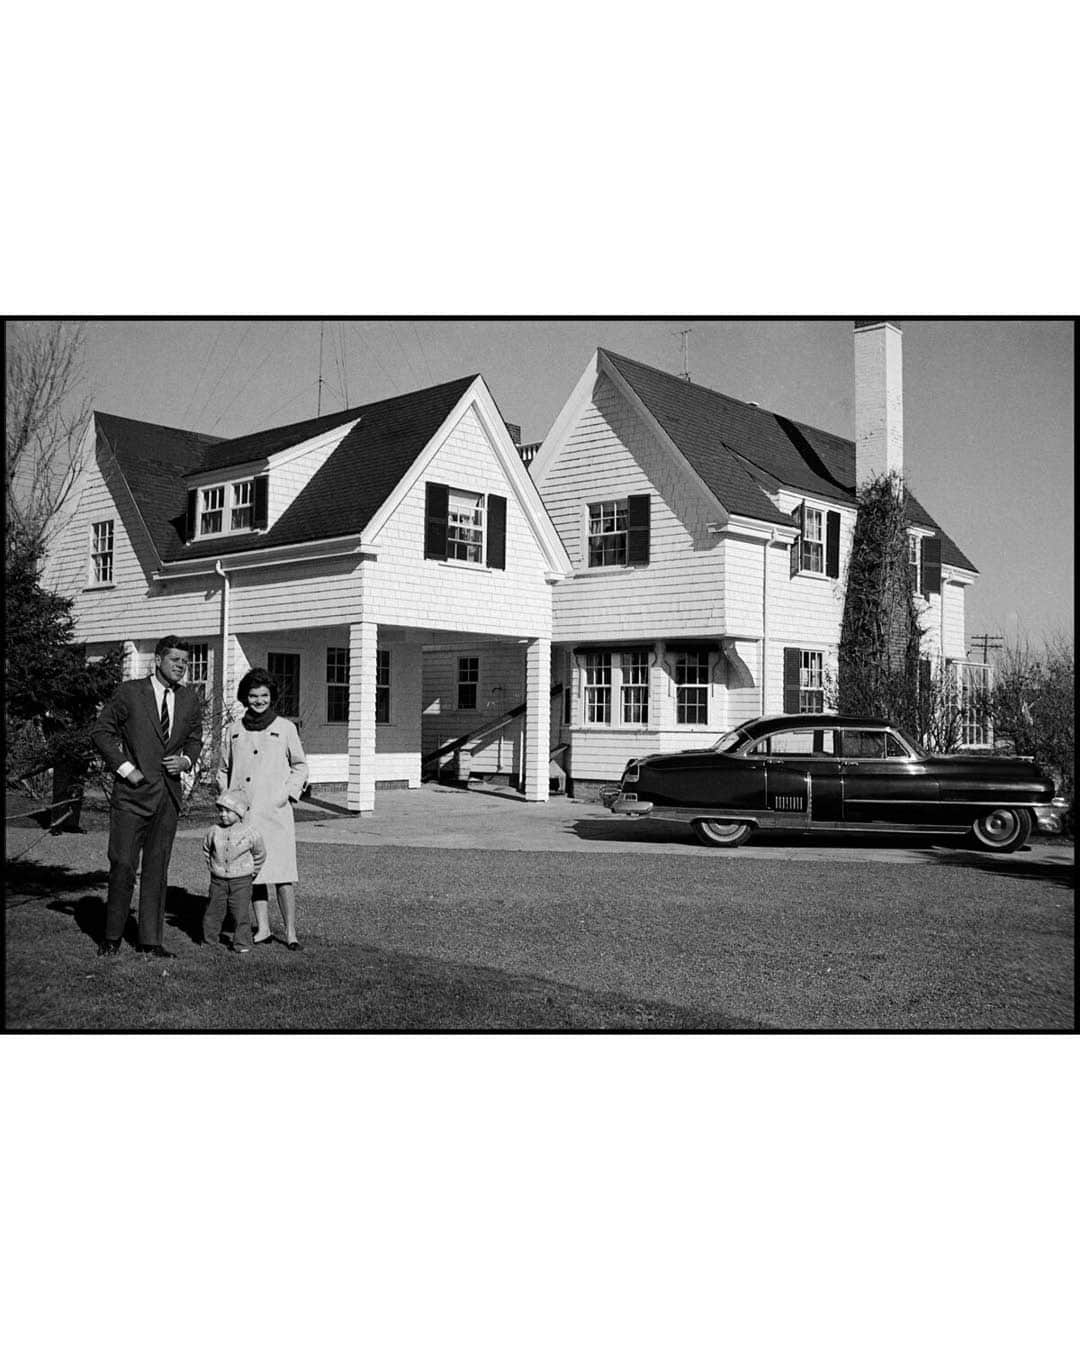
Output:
[{"xmin": 90, "ymin": 633, "xmax": 203, "ymax": 959}]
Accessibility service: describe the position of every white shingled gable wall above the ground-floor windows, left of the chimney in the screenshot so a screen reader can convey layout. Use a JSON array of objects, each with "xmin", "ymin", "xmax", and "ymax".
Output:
[{"xmin": 541, "ymin": 377, "xmax": 726, "ymax": 641}]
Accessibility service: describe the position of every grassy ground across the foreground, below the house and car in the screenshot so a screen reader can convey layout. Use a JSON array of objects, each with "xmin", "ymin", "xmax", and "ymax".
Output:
[{"xmin": 5, "ymin": 830, "xmax": 1075, "ymax": 1031}]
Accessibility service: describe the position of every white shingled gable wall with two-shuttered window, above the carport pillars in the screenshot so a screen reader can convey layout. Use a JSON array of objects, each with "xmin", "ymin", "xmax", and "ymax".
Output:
[{"xmin": 363, "ymin": 408, "xmax": 551, "ymax": 637}]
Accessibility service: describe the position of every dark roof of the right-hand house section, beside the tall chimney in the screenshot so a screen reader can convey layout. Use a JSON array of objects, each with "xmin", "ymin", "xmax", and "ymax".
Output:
[{"xmin": 598, "ymin": 347, "xmax": 976, "ymax": 571}]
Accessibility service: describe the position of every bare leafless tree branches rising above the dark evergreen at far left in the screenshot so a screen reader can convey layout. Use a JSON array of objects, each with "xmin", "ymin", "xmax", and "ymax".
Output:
[{"xmin": 4, "ymin": 321, "xmax": 90, "ymax": 547}]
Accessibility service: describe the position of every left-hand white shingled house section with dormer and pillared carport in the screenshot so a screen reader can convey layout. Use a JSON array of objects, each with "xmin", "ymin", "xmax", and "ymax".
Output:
[{"xmin": 45, "ymin": 375, "xmax": 570, "ymax": 811}]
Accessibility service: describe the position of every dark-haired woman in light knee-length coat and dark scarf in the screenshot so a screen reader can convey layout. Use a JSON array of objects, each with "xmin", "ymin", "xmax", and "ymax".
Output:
[{"xmin": 217, "ymin": 666, "xmax": 308, "ymax": 952}]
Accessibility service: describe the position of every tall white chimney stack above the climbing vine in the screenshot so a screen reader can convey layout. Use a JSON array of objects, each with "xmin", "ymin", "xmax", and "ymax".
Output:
[{"xmin": 855, "ymin": 319, "xmax": 903, "ymax": 487}]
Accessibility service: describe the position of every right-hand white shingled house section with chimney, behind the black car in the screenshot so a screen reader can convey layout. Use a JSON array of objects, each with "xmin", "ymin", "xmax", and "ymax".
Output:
[{"xmin": 531, "ymin": 320, "xmax": 981, "ymax": 795}]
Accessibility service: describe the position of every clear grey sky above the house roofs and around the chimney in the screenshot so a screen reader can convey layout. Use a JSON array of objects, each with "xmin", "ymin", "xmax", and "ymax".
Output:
[{"xmin": 73, "ymin": 319, "xmax": 1073, "ymax": 643}]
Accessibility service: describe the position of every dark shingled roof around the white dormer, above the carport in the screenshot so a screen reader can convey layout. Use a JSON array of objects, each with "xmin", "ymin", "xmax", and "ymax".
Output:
[{"xmin": 95, "ymin": 375, "xmax": 477, "ymax": 563}]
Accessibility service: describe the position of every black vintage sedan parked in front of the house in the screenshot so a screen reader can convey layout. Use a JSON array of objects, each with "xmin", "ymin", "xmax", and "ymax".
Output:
[{"xmin": 601, "ymin": 714, "xmax": 1065, "ymax": 853}]
